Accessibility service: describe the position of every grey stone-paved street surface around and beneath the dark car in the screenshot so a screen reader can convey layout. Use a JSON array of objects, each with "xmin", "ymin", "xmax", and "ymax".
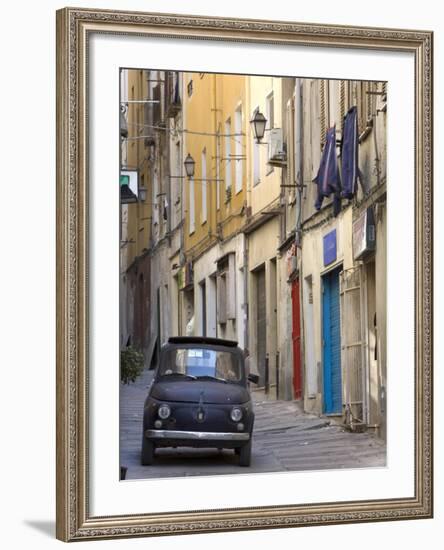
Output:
[{"xmin": 120, "ymin": 370, "xmax": 386, "ymax": 479}]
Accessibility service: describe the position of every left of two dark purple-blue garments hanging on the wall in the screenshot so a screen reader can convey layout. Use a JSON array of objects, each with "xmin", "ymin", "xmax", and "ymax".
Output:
[{"xmin": 313, "ymin": 126, "xmax": 341, "ymax": 215}]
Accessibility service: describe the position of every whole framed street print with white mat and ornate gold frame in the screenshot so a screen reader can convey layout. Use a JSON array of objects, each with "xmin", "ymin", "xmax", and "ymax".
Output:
[{"xmin": 57, "ymin": 8, "xmax": 433, "ymax": 541}]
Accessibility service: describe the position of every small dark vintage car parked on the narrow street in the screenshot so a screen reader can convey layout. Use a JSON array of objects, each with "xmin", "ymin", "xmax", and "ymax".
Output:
[{"xmin": 141, "ymin": 336, "xmax": 258, "ymax": 466}]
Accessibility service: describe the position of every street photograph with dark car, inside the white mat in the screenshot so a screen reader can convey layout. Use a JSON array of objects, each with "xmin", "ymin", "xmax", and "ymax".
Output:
[{"xmin": 119, "ymin": 68, "xmax": 390, "ymax": 481}]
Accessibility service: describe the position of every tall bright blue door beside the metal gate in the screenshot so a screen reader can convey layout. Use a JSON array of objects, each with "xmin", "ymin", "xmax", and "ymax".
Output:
[{"xmin": 322, "ymin": 268, "xmax": 342, "ymax": 414}]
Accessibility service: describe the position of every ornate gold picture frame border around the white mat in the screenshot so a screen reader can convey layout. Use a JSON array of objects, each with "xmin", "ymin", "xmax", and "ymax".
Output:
[{"xmin": 57, "ymin": 8, "xmax": 433, "ymax": 541}]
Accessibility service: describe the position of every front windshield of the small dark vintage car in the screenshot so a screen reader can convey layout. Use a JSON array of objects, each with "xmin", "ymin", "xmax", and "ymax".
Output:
[{"xmin": 159, "ymin": 347, "xmax": 242, "ymax": 382}]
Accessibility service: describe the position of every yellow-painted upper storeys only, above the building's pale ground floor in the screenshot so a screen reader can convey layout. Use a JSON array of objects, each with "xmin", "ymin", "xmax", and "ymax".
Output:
[{"xmin": 184, "ymin": 73, "xmax": 247, "ymax": 256}]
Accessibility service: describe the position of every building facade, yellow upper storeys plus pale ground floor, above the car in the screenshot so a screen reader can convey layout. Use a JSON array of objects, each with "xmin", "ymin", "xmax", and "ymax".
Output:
[{"xmin": 183, "ymin": 73, "xmax": 249, "ymax": 341}]
